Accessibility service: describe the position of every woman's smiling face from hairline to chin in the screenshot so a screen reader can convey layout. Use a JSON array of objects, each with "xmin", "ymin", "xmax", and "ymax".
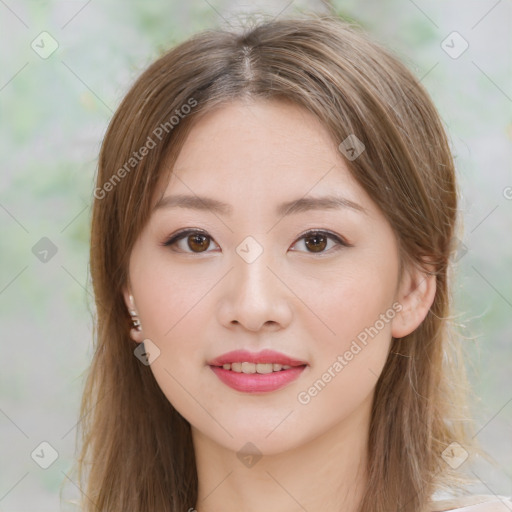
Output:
[{"xmin": 125, "ymin": 101, "xmax": 424, "ymax": 454}]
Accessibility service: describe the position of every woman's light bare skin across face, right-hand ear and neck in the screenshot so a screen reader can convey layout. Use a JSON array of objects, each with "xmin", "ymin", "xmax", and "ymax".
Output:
[{"xmin": 124, "ymin": 100, "xmax": 435, "ymax": 512}]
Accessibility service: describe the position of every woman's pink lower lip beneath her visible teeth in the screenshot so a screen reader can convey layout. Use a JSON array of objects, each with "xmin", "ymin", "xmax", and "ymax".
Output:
[{"xmin": 210, "ymin": 366, "xmax": 306, "ymax": 393}]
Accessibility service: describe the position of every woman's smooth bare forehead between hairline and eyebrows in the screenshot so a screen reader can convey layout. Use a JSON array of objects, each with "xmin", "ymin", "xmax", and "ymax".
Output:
[{"xmin": 153, "ymin": 100, "xmax": 369, "ymax": 213}]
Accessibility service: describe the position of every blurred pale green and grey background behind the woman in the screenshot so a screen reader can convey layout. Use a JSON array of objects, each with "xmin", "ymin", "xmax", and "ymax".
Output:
[{"xmin": 0, "ymin": 0, "xmax": 512, "ymax": 512}]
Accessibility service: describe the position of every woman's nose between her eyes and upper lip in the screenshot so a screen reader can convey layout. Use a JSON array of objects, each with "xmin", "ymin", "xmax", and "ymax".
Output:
[{"xmin": 218, "ymin": 247, "xmax": 293, "ymax": 332}]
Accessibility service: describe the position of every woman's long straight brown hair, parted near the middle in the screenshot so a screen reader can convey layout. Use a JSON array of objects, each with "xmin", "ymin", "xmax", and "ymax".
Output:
[{"xmin": 67, "ymin": 14, "xmax": 480, "ymax": 512}]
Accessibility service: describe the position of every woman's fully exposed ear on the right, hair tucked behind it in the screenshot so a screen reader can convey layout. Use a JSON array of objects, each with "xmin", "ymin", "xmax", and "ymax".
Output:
[{"xmin": 391, "ymin": 260, "xmax": 436, "ymax": 338}]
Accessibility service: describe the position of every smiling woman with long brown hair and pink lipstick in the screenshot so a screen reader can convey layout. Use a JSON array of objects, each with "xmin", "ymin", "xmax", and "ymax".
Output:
[{"xmin": 72, "ymin": 11, "xmax": 512, "ymax": 512}]
